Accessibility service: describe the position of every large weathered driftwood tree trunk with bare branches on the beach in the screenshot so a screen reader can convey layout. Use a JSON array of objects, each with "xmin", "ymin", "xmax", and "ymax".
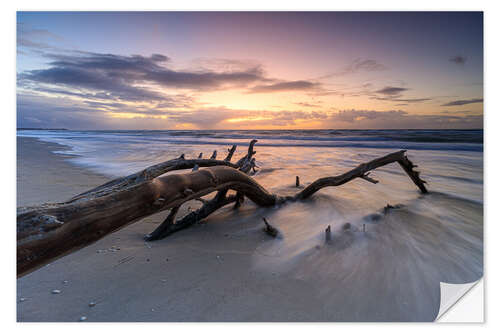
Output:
[{"xmin": 17, "ymin": 140, "xmax": 427, "ymax": 277}]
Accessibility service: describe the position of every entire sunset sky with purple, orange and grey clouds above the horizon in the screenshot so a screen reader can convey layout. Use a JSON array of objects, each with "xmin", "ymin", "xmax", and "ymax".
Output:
[{"xmin": 16, "ymin": 12, "xmax": 483, "ymax": 130}]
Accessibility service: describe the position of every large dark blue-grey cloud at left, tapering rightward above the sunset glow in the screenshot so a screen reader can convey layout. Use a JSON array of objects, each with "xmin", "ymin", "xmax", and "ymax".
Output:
[{"xmin": 18, "ymin": 52, "xmax": 274, "ymax": 102}]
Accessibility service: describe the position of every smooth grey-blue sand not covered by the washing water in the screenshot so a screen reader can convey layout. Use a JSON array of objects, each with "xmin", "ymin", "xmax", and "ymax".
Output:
[{"xmin": 17, "ymin": 138, "xmax": 326, "ymax": 322}]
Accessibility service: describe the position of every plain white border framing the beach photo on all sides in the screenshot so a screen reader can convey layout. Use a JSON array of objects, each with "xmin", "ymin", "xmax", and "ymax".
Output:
[{"xmin": 0, "ymin": 0, "xmax": 500, "ymax": 333}]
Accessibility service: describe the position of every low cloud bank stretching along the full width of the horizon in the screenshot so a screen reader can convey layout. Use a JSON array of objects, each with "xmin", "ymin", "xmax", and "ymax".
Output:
[{"xmin": 17, "ymin": 94, "xmax": 483, "ymax": 129}]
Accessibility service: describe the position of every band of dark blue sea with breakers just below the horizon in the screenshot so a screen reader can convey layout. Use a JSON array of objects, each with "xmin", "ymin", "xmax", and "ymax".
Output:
[{"xmin": 17, "ymin": 130, "xmax": 483, "ymax": 152}]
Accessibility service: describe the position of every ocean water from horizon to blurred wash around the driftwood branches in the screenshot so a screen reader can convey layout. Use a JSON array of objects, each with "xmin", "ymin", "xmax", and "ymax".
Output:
[{"xmin": 17, "ymin": 130, "xmax": 483, "ymax": 321}]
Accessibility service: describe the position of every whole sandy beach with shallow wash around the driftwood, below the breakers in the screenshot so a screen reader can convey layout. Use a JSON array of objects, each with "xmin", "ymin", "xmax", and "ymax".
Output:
[{"xmin": 17, "ymin": 134, "xmax": 483, "ymax": 322}]
